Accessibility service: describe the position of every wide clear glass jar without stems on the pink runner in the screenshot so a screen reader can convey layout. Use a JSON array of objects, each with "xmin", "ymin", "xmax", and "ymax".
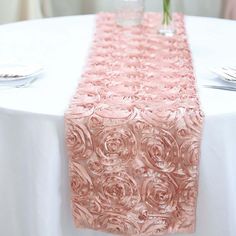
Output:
[{"xmin": 116, "ymin": 0, "xmax": 144, "ymax": 27}]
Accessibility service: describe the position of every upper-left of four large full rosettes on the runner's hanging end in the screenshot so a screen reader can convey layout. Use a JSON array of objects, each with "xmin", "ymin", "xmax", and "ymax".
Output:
[{"xmin": 94, "ymin": 126, "xmax": 137, "ymax": 166}]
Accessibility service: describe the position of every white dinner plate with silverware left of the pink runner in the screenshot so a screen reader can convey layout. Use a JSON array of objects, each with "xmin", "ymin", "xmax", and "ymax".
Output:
[{"xmin": 0, "ymin": 64, "xmax": 43, "ymax": 87}]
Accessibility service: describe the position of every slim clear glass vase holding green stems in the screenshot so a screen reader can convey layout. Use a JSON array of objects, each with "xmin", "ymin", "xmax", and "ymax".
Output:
[{"xmin": 159, "ymin": 0, "xmax": 175, "ymax": 36}]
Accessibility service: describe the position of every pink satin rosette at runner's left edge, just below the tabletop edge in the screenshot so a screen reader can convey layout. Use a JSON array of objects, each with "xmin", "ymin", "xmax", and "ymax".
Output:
[{"xmin": 67, "ymin": 120, "xmax": 93, "ymax": 162}]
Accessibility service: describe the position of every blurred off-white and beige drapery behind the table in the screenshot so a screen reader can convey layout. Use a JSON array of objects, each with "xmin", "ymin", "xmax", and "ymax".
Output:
[{"xmin": 0, "ymin": 0, "xmax": 225, "ymax": 23}]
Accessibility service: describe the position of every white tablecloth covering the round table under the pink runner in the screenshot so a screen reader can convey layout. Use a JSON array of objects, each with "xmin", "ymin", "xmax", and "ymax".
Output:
[{"xmin": 0, "ymin": 16, "xmax": 236, "ymax": 236}]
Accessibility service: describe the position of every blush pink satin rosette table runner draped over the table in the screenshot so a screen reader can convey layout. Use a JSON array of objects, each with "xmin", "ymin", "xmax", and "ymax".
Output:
[{"xmin": 65, "ymin": 13, "xmax": 203, "ymax": 236}]
